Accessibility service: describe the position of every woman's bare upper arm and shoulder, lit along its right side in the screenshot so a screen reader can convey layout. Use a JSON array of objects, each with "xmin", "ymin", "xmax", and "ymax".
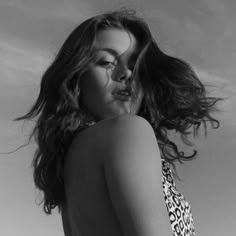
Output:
[{"xmin": 103, "ymin": 116, "xmax": 172, "ymax": 236}]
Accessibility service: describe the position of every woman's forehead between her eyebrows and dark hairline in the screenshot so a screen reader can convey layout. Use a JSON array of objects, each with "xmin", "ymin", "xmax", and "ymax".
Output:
[{"xmin": 95, "ymin": 29, "xmax": 138, "ymax": 56}]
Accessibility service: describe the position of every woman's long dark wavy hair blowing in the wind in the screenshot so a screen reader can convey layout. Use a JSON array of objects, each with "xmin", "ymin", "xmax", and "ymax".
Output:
[{"xmin": 14, "ymin": 10, "xmax": 221, "ymax": 214}]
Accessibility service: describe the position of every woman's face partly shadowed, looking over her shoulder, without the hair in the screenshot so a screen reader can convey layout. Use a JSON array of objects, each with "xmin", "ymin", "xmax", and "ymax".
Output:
[{"xmin": 80, "ymin": 29, "xmax": 143, "ymax": 121}]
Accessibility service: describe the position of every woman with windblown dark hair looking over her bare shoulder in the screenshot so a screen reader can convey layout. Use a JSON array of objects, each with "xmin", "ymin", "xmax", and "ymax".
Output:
[{"xmin": 16, "ymin": 10, "xmax": 220, "ymax": 236}]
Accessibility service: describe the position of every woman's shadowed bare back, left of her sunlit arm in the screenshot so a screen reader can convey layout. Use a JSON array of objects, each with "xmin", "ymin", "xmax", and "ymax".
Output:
[{"xmin": 62, "ymin": 116, "xmax": 123, "ymax": 236}]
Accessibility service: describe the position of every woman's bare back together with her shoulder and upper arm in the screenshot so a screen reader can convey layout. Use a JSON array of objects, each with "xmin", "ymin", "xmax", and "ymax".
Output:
[{"xmin": 62, "ymin": 116, "xmax": 172, "ymax": 236}]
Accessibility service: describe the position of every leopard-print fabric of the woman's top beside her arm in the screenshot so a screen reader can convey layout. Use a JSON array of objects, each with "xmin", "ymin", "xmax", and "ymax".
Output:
[{"xmin": 161, "ymin": 158, "xmax": 195, "ymax": 236}]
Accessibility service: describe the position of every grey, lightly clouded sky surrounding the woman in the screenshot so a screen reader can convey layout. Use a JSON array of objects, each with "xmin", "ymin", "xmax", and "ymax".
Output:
[{"xmin": 0, "ymin": 0, "xmax": 236, "ymax": 236}]
